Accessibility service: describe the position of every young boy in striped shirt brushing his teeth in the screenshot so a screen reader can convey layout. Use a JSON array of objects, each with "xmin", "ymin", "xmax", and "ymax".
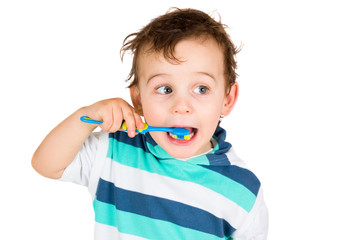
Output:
[{"xmin": 32, "ymin": 9, "xmax": 268, "ymax": 240}]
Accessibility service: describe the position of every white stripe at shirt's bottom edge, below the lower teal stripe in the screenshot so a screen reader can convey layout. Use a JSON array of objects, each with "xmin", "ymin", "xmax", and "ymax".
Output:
[{"xmin": 95, "ymin": 223, "xmax": 147, "ymax": 240}]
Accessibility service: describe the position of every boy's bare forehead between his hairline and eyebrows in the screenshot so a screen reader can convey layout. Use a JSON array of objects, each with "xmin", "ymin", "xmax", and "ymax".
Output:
[{"xmin": 137, "ymin": 38, "xmax": 224, "ymax": 79}]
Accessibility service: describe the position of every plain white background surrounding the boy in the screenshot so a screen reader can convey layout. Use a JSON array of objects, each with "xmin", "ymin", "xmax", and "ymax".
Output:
[{"xmin": 0, "ymin": 0, "xmax": 355, "ymax": 240}]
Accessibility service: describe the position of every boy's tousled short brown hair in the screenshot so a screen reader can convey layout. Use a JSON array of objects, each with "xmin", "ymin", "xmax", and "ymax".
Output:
[{"xmin": 121, "ymin": 8, "xmax": 240, "ymax": 93}]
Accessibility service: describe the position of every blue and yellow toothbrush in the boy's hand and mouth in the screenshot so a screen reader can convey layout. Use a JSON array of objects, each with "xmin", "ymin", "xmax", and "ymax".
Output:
[{"xmin": 80, "ymin": 116, "xmax": 190, "ymax": 140}]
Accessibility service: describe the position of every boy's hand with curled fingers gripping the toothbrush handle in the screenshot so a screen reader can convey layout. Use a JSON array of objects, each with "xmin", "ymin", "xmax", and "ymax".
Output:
[{"xmin": 84, "ymin": 98, "xmax": 144, "ymax": 137}]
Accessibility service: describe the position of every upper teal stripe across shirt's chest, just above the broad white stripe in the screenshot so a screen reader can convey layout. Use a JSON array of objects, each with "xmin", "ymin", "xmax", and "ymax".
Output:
[{"xmin": 107, "ymin": 138, "xmax": 256, "ymax": 212}]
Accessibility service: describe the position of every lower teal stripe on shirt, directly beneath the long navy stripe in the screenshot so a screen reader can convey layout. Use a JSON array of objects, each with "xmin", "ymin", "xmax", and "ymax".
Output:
[{"xmin": 93, "ymin": 199, "xmax": 224, "ymax": 240}]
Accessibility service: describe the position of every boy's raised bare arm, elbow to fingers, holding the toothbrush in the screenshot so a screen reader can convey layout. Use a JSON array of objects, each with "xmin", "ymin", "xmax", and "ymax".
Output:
[{"xmin": 32, "ymin": 98, "xmax": 143, "ymax": 179}]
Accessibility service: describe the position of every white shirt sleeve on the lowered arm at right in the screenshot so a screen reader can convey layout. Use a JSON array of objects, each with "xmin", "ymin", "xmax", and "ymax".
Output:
[{"xmin": 232, "ymin": 189, "xmax": 269, "ymax": 240}]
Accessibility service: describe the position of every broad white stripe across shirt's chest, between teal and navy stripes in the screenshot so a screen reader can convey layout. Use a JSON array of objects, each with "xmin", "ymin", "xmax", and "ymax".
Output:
[{"xmin": 101, "ymin": 161, "xmax": 248, "ymax": 229}]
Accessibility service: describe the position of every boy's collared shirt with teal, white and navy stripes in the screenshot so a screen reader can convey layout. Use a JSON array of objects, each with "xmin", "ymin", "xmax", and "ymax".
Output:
[{"xmin": 62, "ymin": 127, "xmax": 268, "ymax": 240}]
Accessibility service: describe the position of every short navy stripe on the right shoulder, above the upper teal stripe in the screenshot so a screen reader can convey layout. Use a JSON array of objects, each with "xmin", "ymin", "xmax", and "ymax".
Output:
[{"xmin": 201, "ymin": 165, "xmax": 260, "ymax": 196}]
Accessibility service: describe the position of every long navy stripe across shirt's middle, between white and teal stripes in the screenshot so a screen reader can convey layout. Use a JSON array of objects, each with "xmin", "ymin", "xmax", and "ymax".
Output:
[{"xmin": 96, "ymin": 178, "xmax": 235, "ymax": 237}]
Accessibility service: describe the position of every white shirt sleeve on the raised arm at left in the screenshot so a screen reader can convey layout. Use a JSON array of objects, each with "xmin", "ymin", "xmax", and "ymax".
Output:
[{"xmin": 60, "ymin": 132, "xmax": 106, "ymax": 187}]
